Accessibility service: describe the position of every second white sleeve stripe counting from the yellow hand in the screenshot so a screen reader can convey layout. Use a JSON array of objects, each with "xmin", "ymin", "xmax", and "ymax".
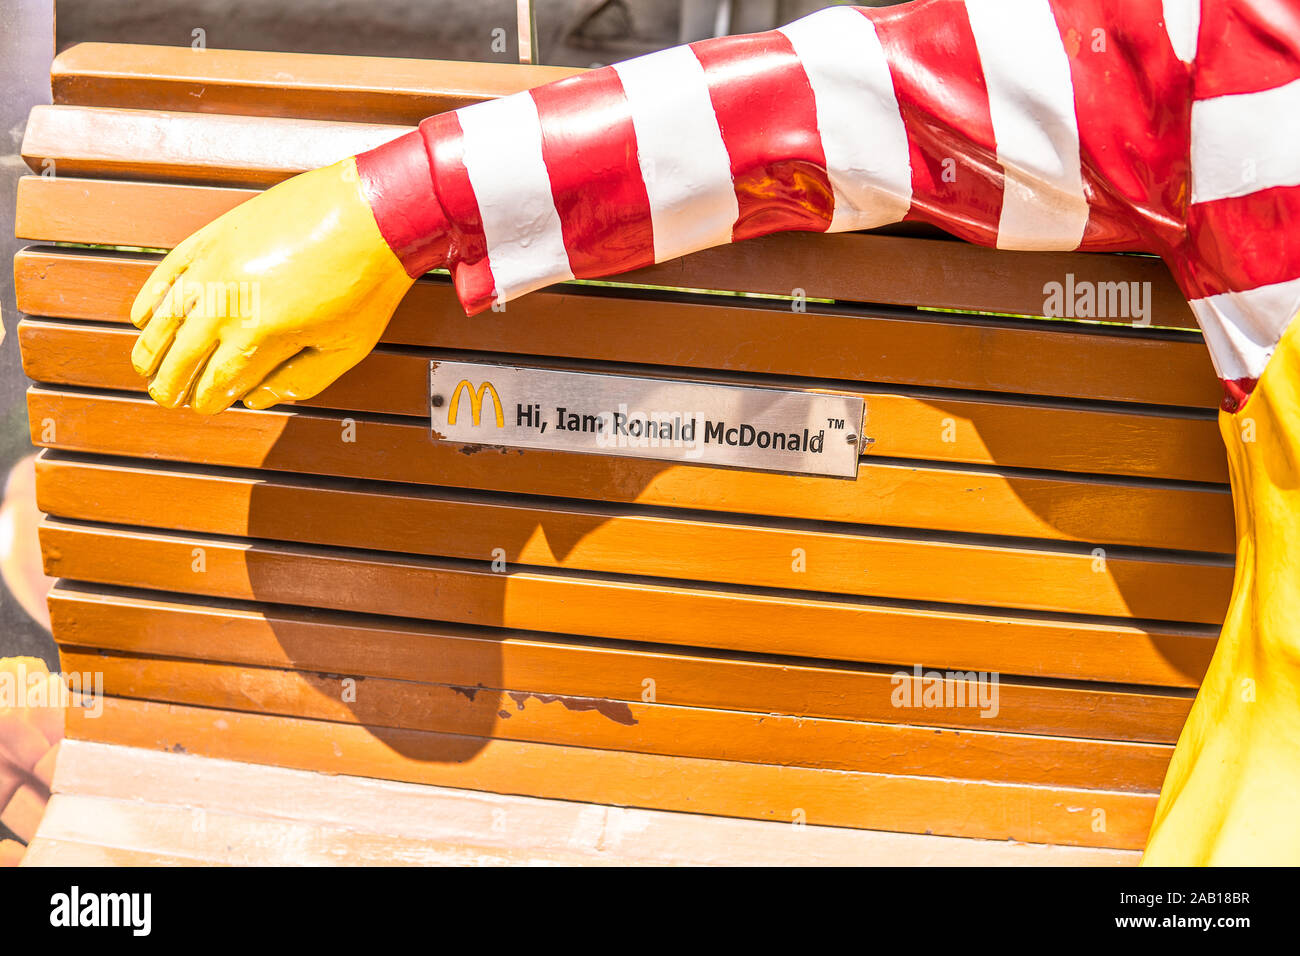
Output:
[{"xmin": 614, "ymin": 47, "xmax": 740, "ymax": 263}]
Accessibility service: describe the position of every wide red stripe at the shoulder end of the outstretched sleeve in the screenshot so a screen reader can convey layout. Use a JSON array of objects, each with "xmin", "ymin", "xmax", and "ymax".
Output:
[{"xmin": 1052, "ymin": 0, "xmax": 1191, "ymax": 252}]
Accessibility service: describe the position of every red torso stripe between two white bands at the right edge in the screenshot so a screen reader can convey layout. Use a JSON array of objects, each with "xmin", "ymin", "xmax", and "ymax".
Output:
[{"xmin": 1180, "ymin": 186, "xmax": 1300, "ymax": 298}]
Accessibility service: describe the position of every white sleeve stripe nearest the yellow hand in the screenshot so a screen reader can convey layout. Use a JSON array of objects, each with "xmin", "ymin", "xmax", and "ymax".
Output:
[{"xmin": 456, "ymin": 92, "xmax": 573, "ymax": 302}]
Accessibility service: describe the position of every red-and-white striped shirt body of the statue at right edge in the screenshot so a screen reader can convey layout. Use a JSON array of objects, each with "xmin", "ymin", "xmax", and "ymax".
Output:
[{"xmin": 1166, "ymin": 0, "xmax": 1300, "ymax": 411}]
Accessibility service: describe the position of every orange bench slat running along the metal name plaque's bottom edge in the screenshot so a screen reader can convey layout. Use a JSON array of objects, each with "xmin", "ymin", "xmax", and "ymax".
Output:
[{"xmin": 27, "ymin": 389, "xmax": 1231, "ymax": 551}]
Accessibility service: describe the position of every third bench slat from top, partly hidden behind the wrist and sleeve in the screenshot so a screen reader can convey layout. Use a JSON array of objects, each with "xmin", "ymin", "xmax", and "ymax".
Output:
[{"xmin": 14, "ymin": 176, "xmax": 1195, "ymax": 328}]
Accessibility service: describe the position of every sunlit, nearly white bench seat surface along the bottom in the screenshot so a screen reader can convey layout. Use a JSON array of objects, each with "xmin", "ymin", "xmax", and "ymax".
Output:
[{"xmin": 38, "ymin": 740, "xmax": 1139, "ymax": 866}]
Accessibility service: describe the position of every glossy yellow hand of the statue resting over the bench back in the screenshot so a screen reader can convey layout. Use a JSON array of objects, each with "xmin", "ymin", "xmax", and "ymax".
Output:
[{"xmin": 131, "ymin": 159, "xmax": 412, "ymax": 415}]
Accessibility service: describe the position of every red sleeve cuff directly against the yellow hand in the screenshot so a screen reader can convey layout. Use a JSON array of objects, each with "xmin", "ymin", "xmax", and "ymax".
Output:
[{"xmin": 356, "ymin": 130, "xmax": 450, "ymax": 278}]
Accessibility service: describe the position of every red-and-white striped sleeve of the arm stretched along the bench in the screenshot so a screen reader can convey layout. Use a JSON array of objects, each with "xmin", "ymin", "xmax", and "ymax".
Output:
[{"xmin": 358, "ymin": 0, "xmax": 1190, "ymax": 313}]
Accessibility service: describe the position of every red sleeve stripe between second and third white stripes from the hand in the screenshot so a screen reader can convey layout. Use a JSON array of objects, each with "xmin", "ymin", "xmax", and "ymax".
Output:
[{"xmin": 683, "ymin": 30, "xmax": 835, "ymax": 239}]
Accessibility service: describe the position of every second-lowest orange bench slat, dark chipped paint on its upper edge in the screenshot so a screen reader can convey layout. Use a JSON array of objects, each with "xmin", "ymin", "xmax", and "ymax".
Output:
[{"xmin": 61, "ymin": 646, "xmax": 1173, "ymax": 793}]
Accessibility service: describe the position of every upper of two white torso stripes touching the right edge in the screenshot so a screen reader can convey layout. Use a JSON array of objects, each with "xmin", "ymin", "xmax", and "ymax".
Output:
[{"xmin": 1192, "ymin": 79, "xmax": 1300, "ymax": 203}]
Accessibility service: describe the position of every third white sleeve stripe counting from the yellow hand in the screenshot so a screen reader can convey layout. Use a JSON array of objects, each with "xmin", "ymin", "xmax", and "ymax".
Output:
[{"xmin": 781, "ymin": 7, "xmax": 911, "ymax": 233}]
